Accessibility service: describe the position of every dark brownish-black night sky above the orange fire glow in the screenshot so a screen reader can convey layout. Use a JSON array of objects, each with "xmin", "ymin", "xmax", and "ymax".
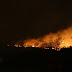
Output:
[{"xmin": 0, "ymin": 0, "xmax": 72, "ymax": 40}]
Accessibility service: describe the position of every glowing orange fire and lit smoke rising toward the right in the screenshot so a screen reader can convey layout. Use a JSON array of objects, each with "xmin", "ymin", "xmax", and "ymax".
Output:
[{"xmin": 15, "ymin": 27, "xmax": 72, "ymax": 50}]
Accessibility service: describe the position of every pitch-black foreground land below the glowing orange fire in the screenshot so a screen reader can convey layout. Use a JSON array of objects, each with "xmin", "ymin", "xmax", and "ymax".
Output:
[{"xmin": 0, "ymin": 47, "xmax": 72, "ymax": 72}]
